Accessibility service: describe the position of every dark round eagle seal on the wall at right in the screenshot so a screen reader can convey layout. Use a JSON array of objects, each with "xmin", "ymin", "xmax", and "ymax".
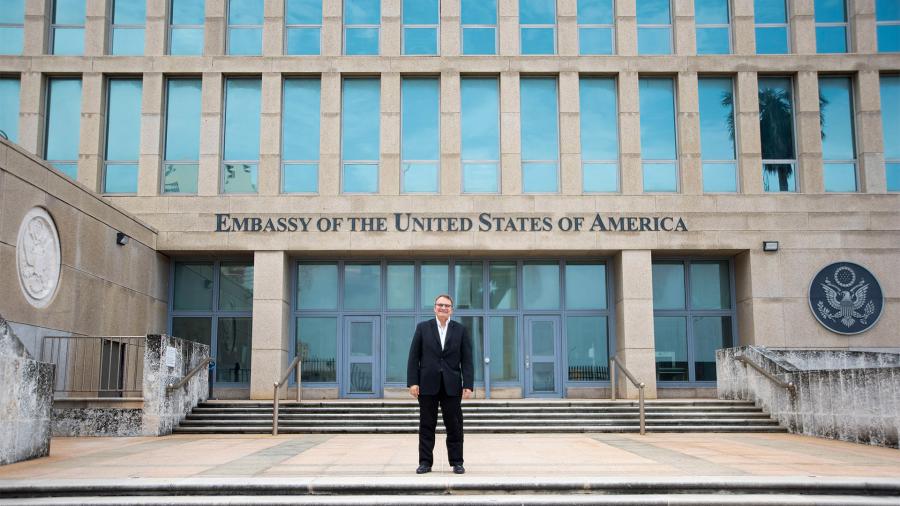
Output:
[{"xmin": 809, "ymin": 262, "xmax": 884, "ymax": 335}]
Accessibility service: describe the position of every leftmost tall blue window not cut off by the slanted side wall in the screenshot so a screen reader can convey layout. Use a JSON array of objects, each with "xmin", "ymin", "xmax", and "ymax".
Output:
[{"xmin": 103, "ymin": 79, "xmax": 142, "ymax": 193}]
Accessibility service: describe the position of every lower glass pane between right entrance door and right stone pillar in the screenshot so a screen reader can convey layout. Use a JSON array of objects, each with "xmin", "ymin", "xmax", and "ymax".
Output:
[{"xmin": 566, "ymin": 316, "xmax": 609, "ymax": 381}]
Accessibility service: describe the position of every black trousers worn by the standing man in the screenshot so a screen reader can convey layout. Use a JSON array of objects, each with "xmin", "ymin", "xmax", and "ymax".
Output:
[{"xmin": 419, "ymin": 380, "xmax": 463, "ymax": 467}]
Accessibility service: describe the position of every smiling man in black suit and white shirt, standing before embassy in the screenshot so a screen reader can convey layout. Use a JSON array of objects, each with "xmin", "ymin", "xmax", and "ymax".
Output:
[{"xmin": 406, "ymin": 295, "xmax": 475, "ymax": 474}]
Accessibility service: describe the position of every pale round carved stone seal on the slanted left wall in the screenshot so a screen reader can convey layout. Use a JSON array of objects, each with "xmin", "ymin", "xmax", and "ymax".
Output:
[{"xmin": 16, "ymin": 207, "xmax": 61, "ymax": 308}]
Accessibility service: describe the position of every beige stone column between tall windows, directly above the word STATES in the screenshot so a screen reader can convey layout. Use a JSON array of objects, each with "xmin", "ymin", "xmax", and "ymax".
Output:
[{"xmin": 500, "ymin": 72, "xmax": 522, "ymax": 194}]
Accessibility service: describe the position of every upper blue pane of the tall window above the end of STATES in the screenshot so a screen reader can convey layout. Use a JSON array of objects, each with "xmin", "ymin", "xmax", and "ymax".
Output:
[{"xmin": 520, "ymin": 77, "xmax": 559, "ymax": 161}]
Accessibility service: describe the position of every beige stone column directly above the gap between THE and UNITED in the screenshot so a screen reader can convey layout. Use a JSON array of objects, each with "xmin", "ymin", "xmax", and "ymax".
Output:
[{"xmin": 378, "ymin": 72, "xmax": 400, "ymax": 195}]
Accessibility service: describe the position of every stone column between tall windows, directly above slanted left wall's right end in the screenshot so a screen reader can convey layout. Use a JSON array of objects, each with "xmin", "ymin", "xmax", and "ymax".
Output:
[{"xmin": 138, "ymin": 72, "xmax": 165, "ymax": 197}]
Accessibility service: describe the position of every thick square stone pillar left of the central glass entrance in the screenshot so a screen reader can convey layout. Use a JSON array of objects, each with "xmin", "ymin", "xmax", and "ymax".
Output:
[{"xmin": 250, "ymin": 251, "xmax": 291, "ymax": 399}]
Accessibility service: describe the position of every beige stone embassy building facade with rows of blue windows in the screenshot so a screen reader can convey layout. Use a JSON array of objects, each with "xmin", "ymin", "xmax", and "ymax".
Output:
[{"xmin": 0, "ymin": 0, "xmax": 900, "ymax": 399}]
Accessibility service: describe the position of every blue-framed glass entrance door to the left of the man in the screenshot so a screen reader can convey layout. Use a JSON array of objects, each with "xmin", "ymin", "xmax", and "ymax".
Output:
[{"xmin": 341, "ymin": 316, "xmax": 381, "ymax": 397}]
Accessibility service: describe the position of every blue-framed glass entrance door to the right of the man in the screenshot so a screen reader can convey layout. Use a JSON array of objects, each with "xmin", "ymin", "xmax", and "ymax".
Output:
[{"xmin": 525, "ymin": 316, "xmax": 562, "ymax": 397}]
